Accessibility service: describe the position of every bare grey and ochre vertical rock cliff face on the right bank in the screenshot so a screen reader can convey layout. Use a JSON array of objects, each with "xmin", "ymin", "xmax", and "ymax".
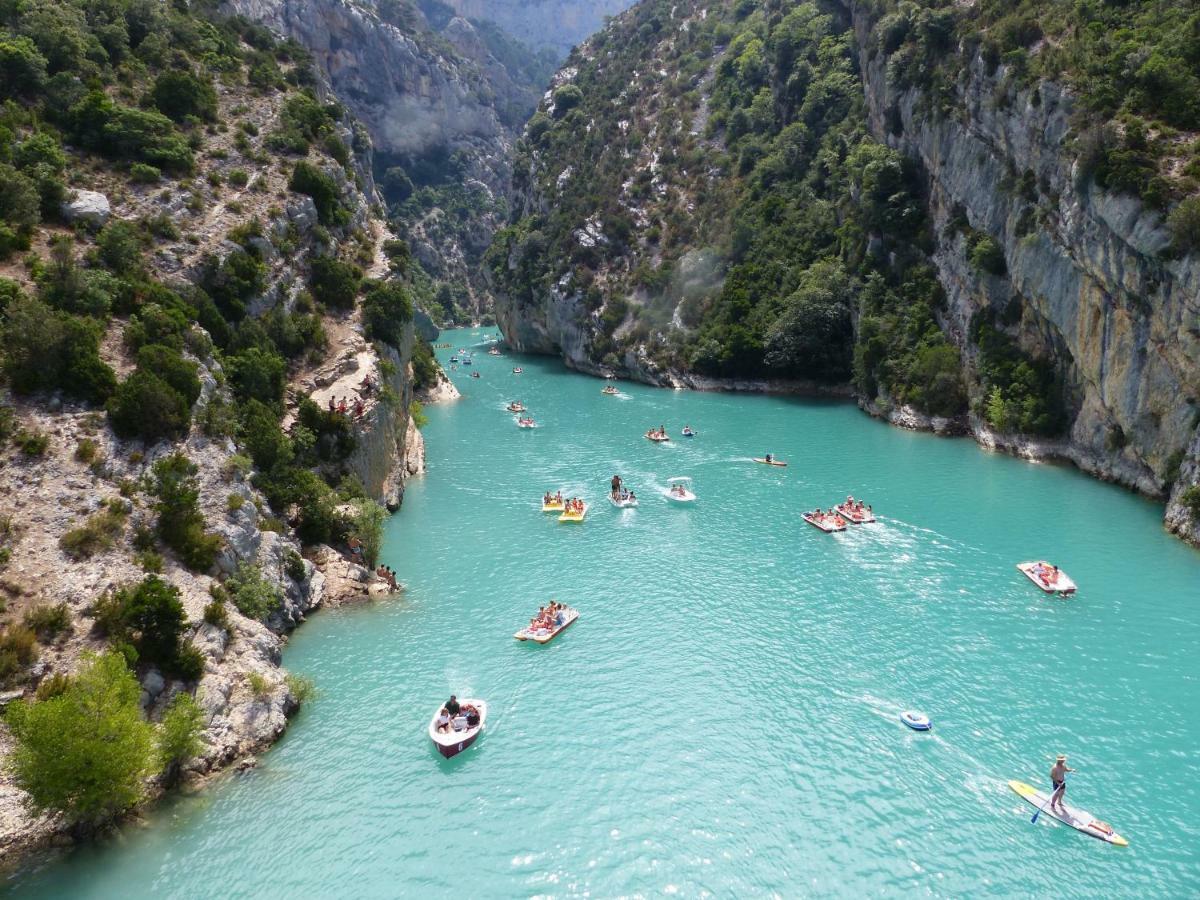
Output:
[{"xmin": 856, "ymin": 5, "xmax": 1200, "ymax": 496}]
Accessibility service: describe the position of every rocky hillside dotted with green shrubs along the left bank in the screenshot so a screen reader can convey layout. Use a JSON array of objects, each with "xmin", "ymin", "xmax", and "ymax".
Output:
[{"xmin": 0, "ymin": 0, "xmax": 412, "ymax": 820}]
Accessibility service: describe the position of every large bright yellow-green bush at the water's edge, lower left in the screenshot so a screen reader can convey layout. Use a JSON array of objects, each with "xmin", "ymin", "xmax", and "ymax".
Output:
[{"xmin": 6, "ymin": 653, "xmax": 156, "ymax": 828}]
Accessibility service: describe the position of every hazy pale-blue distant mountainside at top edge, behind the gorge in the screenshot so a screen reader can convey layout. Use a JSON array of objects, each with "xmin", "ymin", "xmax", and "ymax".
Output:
[{"xmin": 448, "ymin": 0, "xmax": 635, "ymax": 59}]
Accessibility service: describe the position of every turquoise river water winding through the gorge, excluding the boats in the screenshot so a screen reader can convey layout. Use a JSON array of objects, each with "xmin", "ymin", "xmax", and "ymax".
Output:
[{"xmin": 12, "ymin": 332, "xmax": 1200, "ymax": 898}]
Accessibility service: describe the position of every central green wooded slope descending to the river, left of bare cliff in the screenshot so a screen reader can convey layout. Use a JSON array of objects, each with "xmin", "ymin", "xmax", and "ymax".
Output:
[{"xmin": 492, "ymin": 0, "xmax": 966, "ymax": 414}]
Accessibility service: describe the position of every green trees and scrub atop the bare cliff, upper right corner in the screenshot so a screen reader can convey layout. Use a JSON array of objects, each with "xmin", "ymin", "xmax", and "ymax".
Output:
[{"xmin": 859, "ymin": 0, "xmax": 1200, "ymax": 224}]
